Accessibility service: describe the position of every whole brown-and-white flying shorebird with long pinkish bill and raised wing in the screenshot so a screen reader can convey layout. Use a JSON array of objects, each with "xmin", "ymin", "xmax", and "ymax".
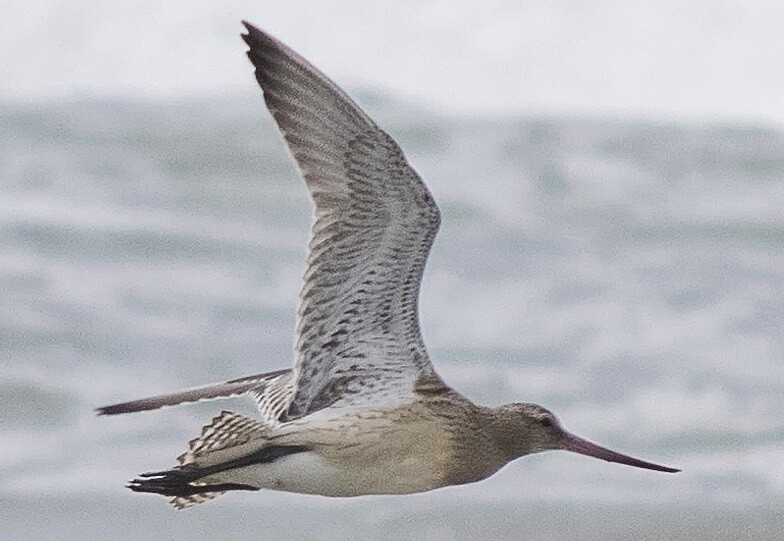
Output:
[{"xmin": 97, "ymin": 21, "xmax": 680, "ymax": 509}]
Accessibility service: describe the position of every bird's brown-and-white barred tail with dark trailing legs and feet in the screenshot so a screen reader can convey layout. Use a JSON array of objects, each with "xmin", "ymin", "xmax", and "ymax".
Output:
[{"xmin": 126, "ymin": 411, "xmax": 308, "ymax": 509}]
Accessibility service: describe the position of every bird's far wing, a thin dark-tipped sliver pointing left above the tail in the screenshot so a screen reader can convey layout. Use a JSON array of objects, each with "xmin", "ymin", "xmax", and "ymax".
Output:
[{"xmin": 96, "ymin": 369, "xmax": 291, "ymax": 415}]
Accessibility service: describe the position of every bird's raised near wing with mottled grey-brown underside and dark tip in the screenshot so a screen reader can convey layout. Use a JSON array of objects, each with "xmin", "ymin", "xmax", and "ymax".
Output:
[{"xmin": 243, "ymin": 23, "xmax": 440, "ymax": 418}]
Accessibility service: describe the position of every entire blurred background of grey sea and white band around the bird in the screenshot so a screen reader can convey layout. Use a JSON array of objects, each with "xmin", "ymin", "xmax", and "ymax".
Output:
[{"xmin": 0, "ymin": 0, "xmax": 784, "ymax": 539}]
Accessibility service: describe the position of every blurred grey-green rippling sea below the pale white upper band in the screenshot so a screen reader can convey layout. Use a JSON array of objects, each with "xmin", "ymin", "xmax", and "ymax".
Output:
[{"xmin": 0, "ymin": 92, "xmax": 784, "ymax": 540}]
